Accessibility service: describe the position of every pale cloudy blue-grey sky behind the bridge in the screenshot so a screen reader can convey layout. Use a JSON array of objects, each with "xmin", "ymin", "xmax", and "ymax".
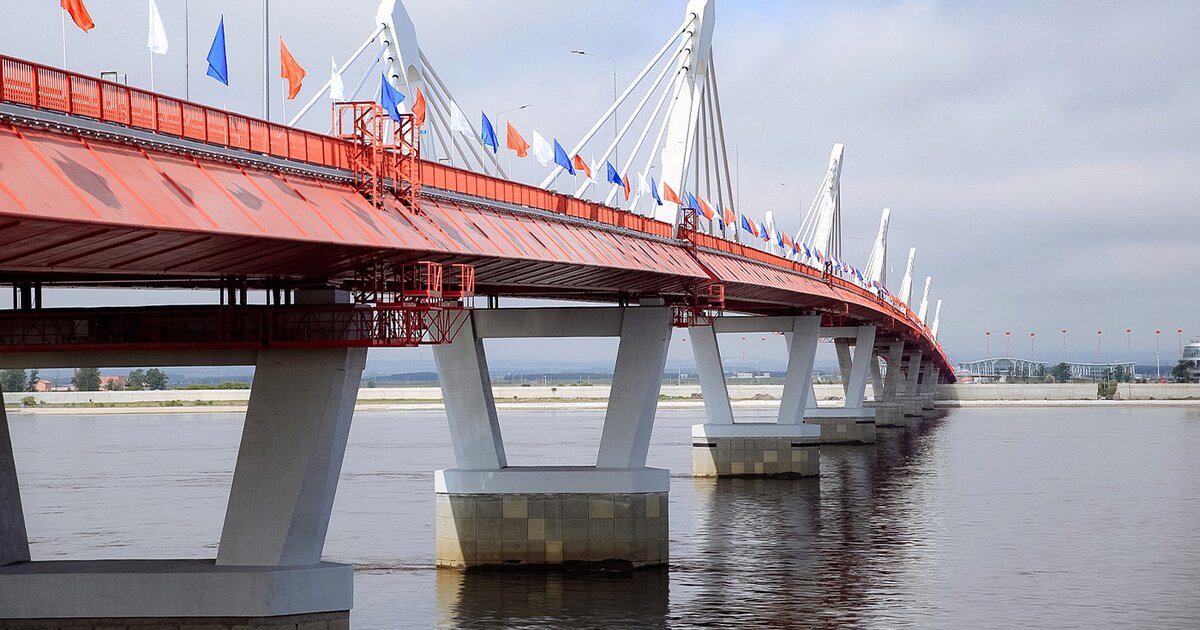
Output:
[{"xmin": 0, "ymin": 0, "xmax": 1200, "ymax": 364}]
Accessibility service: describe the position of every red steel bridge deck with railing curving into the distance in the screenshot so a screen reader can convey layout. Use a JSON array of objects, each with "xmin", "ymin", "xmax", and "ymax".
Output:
[{"xmin": 0, "ymin": 55, "xmax": 949, "ymax": 373}]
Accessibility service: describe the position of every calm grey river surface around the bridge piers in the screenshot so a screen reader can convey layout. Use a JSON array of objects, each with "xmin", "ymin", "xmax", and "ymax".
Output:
[{"xmin": 8, "ymin": 408, "xmax": 1200, "ymax": 629}]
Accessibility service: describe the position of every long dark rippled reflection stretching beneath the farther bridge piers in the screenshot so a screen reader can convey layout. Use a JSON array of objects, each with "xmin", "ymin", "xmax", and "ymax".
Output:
[{"xmin": 686, "ymin": 414, "xmax": 942, "ymax": 626}]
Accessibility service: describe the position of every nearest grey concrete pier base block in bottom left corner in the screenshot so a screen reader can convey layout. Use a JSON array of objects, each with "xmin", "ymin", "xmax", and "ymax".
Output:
[{"xmin": 0, "ymin": 560, "xmax": 354, "ymax": 614}]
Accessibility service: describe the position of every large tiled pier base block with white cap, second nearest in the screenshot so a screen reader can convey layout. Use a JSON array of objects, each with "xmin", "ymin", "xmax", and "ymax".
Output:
[{"xmin": 436, "ymin": 467, "xmax": 670, "ymax": 570}]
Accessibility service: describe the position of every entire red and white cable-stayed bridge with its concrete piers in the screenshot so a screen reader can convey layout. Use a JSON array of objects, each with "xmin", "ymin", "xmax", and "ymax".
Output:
[{"xmin": 0, "ymin": 0, "xmax": 954, "ymax": 625}]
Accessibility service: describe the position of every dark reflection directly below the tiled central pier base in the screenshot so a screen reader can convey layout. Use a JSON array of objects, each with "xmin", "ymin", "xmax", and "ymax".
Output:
[{"xmin": 437, "ymin": 568, "xmax": 668, "ymax": 629}]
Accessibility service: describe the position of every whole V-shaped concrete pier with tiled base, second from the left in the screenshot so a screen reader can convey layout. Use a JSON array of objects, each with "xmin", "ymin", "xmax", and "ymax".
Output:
[{"xmin": 433, "ymin": 300, "xmax": 676, "ymax": 569}]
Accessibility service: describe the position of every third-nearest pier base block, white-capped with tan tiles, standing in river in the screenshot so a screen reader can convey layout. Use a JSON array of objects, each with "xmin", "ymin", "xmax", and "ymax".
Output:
[{"xmin": 691, "ymin": 422, "xmax": 821, "ymax": 478}]
